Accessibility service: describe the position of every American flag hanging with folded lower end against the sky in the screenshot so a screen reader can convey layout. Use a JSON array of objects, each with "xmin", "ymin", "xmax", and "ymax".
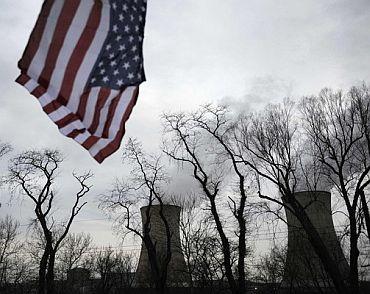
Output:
[{"xmin": 16, "ymin": 0, "xmax": 147, "ymax": 163}]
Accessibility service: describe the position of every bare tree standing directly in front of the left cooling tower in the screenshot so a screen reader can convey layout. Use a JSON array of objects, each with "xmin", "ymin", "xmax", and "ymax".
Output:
[{"xmin": 100, "ymin": 139, "xmax": 173, "ymax": 293}]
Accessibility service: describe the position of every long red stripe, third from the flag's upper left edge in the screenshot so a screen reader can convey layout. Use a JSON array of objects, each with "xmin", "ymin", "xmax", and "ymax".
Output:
[{"xmin": 58, "ymin": 1, "xmax": 102, "ymax": 104}]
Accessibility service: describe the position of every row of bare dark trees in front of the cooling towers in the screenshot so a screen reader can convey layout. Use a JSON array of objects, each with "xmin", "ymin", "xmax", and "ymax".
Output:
[{"xmin": 1, "ymin": 84, "xmax": 370, "ymax": 294}]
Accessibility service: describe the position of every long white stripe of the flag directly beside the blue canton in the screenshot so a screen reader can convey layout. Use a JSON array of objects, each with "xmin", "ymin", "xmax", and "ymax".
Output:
[{"xmin": 67, "ymin": 4, "xmax": 110, "ymax": 112}]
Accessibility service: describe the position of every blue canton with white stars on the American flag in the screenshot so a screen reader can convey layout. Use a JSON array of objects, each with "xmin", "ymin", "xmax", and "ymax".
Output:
[{"xmin": 90, "ymin": 0, "xmax": 146, "ymax": 89}]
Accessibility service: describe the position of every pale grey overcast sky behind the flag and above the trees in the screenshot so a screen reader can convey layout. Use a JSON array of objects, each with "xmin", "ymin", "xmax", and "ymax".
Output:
[{"xmin": 0, "ymin": 0, "xmax": 370, "ymax": 253}]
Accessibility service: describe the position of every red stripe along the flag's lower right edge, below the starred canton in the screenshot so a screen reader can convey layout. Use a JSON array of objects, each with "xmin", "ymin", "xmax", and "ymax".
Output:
[{"xmin": 94, "ymin": 87, "xmax": 139, "ymax": 163}]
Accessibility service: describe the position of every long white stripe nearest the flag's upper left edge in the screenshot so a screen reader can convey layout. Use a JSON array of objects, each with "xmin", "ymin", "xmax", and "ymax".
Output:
[{"xmin": 27, "ymin": 1, "xmax": 65, "ymax": 81}]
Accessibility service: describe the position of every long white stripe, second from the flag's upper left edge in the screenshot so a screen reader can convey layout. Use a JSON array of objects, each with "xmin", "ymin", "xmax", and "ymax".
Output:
[{"xmin": 48, "ymin": 1, "xmax": 94, "ymax": 98}]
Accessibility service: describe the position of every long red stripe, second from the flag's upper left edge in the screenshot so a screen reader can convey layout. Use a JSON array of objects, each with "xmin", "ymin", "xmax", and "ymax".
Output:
[{"xmin": 38, "ymin": 0, "xmax": 80, "ymax": 88}]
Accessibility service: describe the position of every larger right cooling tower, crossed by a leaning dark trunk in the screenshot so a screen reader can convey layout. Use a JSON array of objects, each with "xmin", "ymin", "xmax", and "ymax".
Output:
[{"xmin": 283, "ymin": 191, "xmax": 349, "ymax": 288}]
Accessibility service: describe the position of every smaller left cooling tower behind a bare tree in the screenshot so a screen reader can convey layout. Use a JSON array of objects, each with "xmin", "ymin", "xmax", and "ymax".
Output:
[{"xmin": 134, "ymin": 205, "xmax": 190, "ymax": 287}]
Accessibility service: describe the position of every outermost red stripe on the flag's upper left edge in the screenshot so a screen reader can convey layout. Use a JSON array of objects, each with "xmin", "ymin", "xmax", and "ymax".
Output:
[{"xmin": 18, "ymin": 0, "xmax": 55, "ymax": 72}]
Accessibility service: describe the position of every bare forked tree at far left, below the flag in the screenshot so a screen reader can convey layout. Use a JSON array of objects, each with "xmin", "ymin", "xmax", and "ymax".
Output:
[{"xmin": 6, "ymin": 150, "xmax": 92, "ymax": 294}]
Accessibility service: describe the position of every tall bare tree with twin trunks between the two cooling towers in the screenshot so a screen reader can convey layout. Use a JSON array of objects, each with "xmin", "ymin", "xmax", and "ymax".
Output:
[{"xmin": 163, "ymin": 105, "xmax": 253, "ymax": 294}]
